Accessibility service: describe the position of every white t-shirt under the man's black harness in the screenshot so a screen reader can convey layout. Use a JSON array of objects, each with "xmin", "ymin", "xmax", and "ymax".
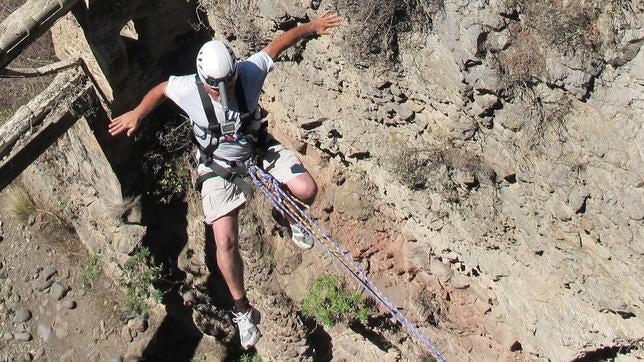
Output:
[{"xmin": 165, "ymin": 51, "xmax": 273, "ymax": 173}]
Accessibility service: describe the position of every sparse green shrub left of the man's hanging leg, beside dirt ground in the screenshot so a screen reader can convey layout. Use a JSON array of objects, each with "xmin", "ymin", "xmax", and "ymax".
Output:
[{"xmin": 119, "ymin": 248, "xmax": 162, "ymax": 318}]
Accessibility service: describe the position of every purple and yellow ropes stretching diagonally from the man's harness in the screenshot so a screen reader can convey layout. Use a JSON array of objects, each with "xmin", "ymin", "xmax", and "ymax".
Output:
[{"xmin": 248, "ymin": 166, "xmax": 446, "ymax": 362}]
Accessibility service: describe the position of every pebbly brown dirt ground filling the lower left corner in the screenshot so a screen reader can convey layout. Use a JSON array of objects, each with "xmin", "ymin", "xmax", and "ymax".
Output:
[{"xmin": 0, "ymin": 185, "xmax": 131, "ymax": 361}]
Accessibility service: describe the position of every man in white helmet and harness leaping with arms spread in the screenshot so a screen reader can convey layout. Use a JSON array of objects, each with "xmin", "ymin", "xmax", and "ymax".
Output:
[{"xmin": 109, "ymin": 12, "xmax": 340, "ymax": 349}]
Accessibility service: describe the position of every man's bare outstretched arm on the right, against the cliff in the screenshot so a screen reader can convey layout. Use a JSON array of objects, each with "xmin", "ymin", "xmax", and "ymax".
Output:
[{"xmin": 263, "ymin": 11, "xmax": 340, "ymax": 60}]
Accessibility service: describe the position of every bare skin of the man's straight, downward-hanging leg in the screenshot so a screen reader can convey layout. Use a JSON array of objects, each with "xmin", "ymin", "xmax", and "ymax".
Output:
[{"xmin": 212, "ymin": 210, "xmax": 246, "ymax": 300}]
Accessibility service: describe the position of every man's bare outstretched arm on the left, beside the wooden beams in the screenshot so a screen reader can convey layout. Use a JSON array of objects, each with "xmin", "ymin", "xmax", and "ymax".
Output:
[{"xmin": 109, "ymin": 82, "xmax": 168, "ymax": 137}]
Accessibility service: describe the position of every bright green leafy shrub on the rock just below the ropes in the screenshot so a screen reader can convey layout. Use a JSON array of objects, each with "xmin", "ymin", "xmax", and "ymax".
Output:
[{"xmin": 302, "ymin": 276, "xmax": 371, "ymax": 326}]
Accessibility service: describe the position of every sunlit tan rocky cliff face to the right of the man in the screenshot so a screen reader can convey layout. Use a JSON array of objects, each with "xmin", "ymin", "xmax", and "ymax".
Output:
[{"xmin": 208, "ymin": 1, "xmax": 644, "ymax": 360}]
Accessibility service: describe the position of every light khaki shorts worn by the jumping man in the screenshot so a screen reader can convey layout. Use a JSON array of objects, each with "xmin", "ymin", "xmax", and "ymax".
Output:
[{"xmin": 201, "ymin": 144, "xmax": 307, "ymax": 224}]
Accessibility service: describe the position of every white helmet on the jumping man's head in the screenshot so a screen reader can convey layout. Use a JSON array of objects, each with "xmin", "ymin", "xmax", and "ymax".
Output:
[{"xmin": 197, "ymin": 40, "xmax": 237, "ymax": 89}]
